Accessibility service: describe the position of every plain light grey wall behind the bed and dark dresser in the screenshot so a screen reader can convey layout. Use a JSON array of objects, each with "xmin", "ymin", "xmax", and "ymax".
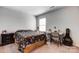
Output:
[{"xmin": 0, "ymin": 7, "xmax": 36, "ymax": 32}]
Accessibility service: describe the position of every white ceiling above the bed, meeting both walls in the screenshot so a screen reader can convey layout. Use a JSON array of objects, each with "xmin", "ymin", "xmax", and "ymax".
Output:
[{"xmin": 6, "ymin": 6, "xmax": 62, "ymax": 16}]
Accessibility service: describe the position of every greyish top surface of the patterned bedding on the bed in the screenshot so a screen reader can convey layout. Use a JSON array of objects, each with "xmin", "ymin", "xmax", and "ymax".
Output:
[{"xmin": 15, "ymin": 30, "xmax": 43, "ymax": 41}]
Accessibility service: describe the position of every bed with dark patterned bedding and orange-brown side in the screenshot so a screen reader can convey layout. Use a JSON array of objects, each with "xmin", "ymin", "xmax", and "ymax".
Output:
[{"xmin": 15, "ymin": 30, "xmax": 46, "ymax": 53}]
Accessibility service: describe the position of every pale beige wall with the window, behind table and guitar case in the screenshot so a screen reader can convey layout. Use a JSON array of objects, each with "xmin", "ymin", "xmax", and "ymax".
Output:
[{"xmin": 37, "ymin": 6, "xmax": 79, "ymax": 46}]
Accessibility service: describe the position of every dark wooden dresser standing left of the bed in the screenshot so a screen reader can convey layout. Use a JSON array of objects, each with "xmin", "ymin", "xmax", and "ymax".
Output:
[{"xmin": 1, "ymin": 33, "xmax": 15, "ymax": 46}]
